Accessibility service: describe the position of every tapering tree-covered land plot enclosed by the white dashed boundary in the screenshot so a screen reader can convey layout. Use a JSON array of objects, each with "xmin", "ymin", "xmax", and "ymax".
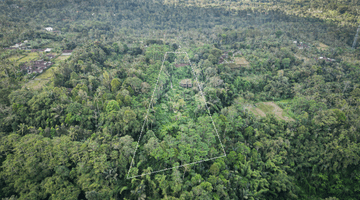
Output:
[{"xmin": 127, "ymin": 53, "xmax": 226, "ymax": 178}]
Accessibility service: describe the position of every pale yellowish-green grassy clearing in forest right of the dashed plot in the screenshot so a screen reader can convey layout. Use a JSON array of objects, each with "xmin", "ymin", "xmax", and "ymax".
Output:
[{"xmin": 246, "ymin": 102, "xmax": 295, "ymax": 121}]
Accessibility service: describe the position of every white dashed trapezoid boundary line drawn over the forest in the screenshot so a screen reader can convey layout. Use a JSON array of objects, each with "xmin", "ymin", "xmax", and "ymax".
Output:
[{"xmin": 127, "ymin": 52, "xmax": 226, "ymax": 179}]
